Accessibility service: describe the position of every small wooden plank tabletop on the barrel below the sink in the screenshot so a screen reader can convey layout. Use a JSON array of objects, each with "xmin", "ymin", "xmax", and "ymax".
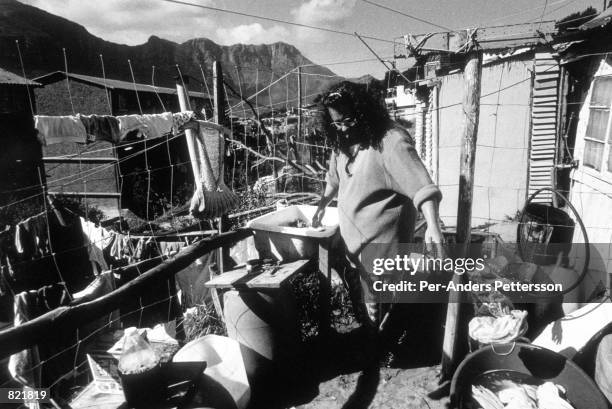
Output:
[{"xmin": 204, "ymin": 260, "xmax": 309, "ymax": 290}]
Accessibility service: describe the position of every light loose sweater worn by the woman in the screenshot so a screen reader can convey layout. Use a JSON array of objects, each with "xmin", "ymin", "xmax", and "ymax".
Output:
[{"xmin": 326, "ymin": 127, "xmax": 442, "ymax": 256}]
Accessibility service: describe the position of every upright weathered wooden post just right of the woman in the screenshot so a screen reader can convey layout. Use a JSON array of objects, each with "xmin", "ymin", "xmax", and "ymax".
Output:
[{"xmin": 441, "ymin": 51, "xmax": 482, "ymax": 379}]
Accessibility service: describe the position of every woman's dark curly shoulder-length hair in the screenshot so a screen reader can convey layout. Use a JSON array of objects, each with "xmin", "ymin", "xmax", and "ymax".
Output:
[{"xmin": 317, "ymin": 81, "xmax": 392, "ymax": 152}]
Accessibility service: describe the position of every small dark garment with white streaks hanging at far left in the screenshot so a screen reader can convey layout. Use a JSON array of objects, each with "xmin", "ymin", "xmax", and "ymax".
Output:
[{"xmin": 15, "ymin": 213, "xmax": 51, "ymax": 259}]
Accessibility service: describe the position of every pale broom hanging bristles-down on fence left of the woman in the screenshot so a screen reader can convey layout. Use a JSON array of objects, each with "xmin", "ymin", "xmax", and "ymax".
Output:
[{"xmin": 189, "ymin": 121, "xmax": 238, "ymax": 219}]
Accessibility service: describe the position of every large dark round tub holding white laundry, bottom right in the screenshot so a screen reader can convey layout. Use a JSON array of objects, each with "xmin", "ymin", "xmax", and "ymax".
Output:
[{"xmin": 451, "ymin": 342, "xmax": 608, "ymax": 409}]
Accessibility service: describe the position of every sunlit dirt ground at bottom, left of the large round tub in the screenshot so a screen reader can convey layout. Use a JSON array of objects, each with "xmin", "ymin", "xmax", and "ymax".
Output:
[{"xmin": 296, "ymin": 366, "xmax": 449, "ymax": 409}]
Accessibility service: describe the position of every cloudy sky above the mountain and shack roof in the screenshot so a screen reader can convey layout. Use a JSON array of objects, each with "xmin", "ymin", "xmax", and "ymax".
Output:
[{"xmin": 20, "ymin": 0, "xmax": 604, "ymax": 78}]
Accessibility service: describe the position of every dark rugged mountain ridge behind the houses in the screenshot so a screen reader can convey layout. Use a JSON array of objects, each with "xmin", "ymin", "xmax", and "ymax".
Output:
[{"xmin": 0, "ymin": 0, "xmax": 342, "ymax": 110}]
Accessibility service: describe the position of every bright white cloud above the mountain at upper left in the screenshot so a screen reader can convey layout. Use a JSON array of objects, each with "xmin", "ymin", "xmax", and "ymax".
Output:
[{"xmin": 21, "ymin": 0, "xmax": 217, "ymax": 45}]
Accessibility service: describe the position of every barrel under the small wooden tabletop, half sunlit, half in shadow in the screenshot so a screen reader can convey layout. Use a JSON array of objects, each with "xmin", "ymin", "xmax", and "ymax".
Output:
[{"xmin": 223, "ymin": 289, "xmax": 318, "ymax": 408}]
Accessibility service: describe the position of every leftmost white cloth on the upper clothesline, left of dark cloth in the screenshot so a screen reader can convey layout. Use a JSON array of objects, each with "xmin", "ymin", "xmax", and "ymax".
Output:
[{"xmin": 34, "ymin": 115, "xmax": 87, "ymax": 145}]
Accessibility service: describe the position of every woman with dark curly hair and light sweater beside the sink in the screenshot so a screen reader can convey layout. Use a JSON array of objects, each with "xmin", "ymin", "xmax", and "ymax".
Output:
[{"xmin": 312, "ymin": 81, "xmax": 444, "ymax": 358}]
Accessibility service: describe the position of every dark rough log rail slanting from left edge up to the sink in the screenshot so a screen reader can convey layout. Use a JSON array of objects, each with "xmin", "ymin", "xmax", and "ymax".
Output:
[{"xmin": 0, "ymin": 229, "xmax": 252, "ymax": 359}]
